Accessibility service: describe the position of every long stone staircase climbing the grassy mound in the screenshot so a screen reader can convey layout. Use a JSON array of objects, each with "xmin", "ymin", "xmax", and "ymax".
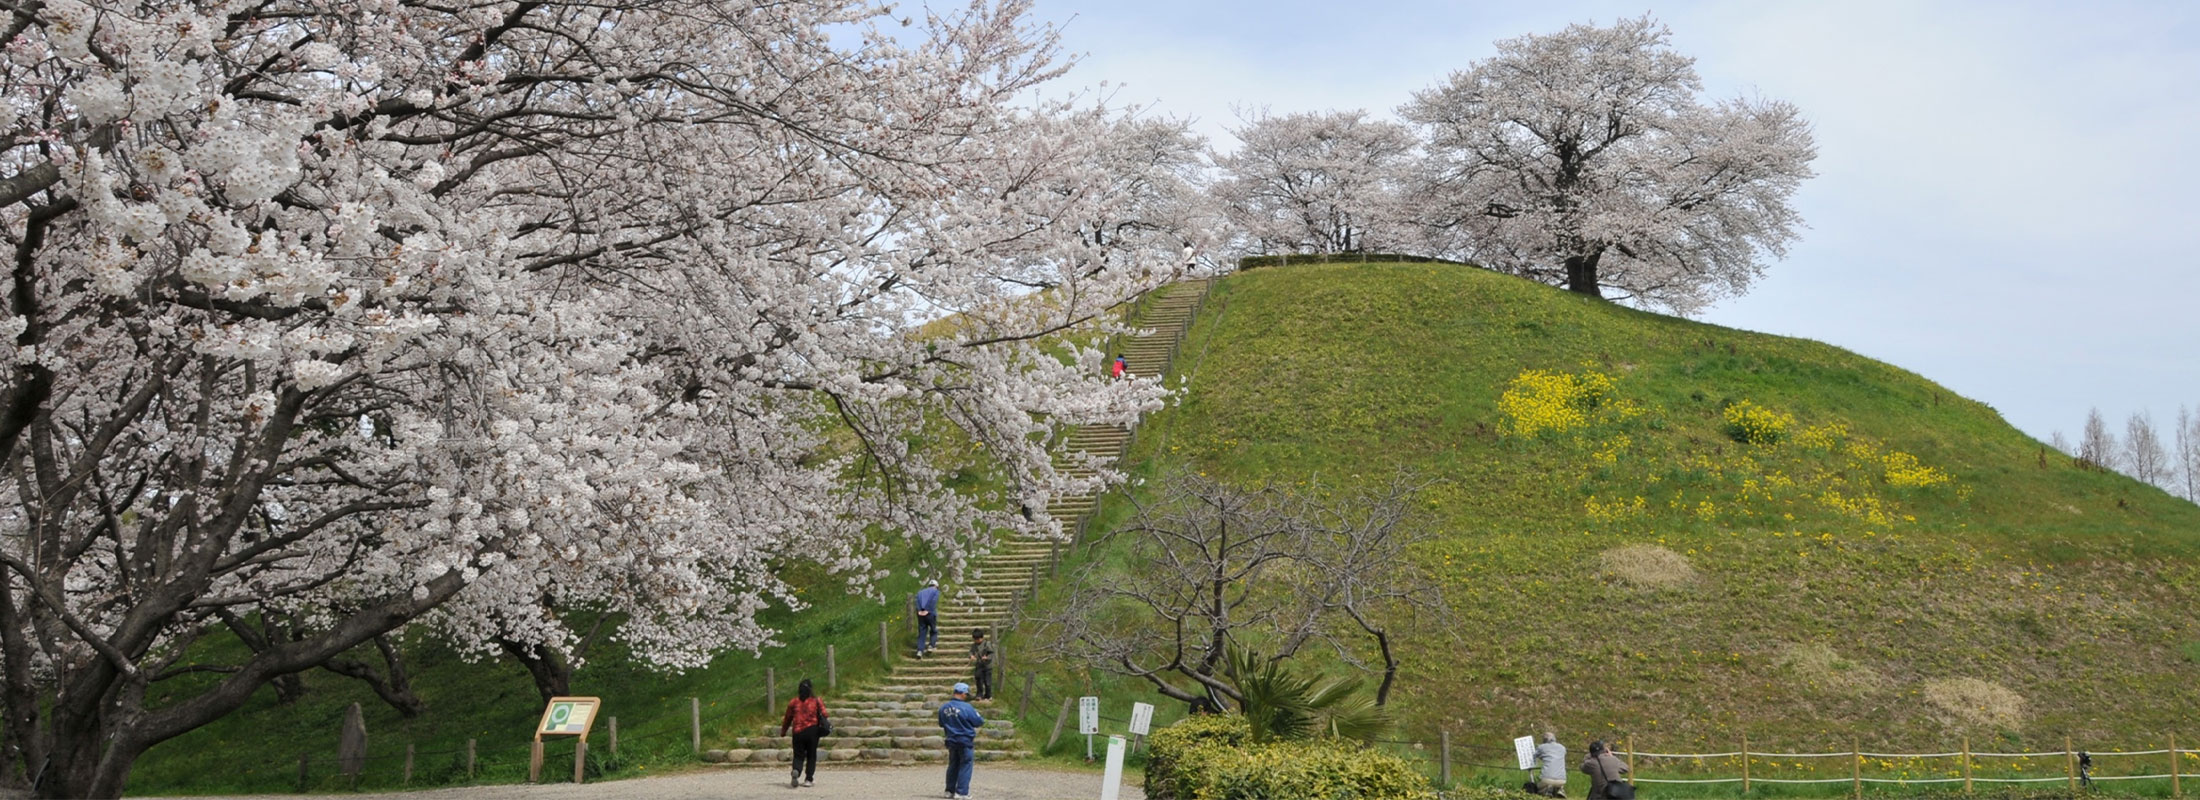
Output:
[{"xmin": 704, "ymin": 279, "xmax": 1208, "ymax": 767}]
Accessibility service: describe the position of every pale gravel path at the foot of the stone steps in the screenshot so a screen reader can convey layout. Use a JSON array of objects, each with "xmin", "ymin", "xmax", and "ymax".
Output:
[{"xmin": 152, "ymin": 765, "xmax": 1146, "ymax": 800}]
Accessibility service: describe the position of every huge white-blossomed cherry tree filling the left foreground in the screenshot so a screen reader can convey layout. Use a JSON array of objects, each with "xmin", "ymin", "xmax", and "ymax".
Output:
[{"xmin": 0, "ymin": 0, "xmax": 1184, "ymax": 798}]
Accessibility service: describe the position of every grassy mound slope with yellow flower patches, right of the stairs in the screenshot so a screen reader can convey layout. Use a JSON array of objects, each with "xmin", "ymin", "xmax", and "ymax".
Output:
[{"xmin": 1108, "ymin": 264, "xmax": 2200, "ymax": 756}]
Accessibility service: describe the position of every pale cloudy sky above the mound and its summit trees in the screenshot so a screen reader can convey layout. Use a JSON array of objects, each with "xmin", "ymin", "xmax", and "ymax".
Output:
[{"xmin": 1036, "ymin": 0, "xmax": 2200, "ymax": 450}]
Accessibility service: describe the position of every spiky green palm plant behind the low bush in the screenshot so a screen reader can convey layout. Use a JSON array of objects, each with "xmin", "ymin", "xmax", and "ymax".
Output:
[{"xmin": 1228, "ymin": 646, "xmax": 1395, "ymax": 743}]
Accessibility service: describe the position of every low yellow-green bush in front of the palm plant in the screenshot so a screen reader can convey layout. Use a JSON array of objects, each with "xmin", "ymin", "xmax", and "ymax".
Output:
[{"xmin": 1146, "ymin": 714, "xmax": 1432, "ymax": 800}]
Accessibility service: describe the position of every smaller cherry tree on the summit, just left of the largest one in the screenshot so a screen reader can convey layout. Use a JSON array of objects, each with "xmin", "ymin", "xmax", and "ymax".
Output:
[{"xmin": 1214, "ymin": 110, "xmax": 1417, "ymax": 253}]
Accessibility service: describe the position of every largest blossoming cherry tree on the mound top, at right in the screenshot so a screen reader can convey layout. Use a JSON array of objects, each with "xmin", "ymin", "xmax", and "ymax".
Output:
[{"xmin": 1401, "ymin": 15, "xmax": 1815, "ymax": 312}]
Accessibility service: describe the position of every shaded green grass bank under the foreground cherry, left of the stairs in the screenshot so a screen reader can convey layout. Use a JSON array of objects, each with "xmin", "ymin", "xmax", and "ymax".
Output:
[{"xmin": 128, "ymin": 558, "xmax": 915, "ymax": 796}]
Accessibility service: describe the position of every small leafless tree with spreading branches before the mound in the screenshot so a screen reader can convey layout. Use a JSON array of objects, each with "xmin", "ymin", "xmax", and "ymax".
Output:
[{"xmin": 1032, "ymin": 475, "xmax": 1450, "ymax": 705}]
